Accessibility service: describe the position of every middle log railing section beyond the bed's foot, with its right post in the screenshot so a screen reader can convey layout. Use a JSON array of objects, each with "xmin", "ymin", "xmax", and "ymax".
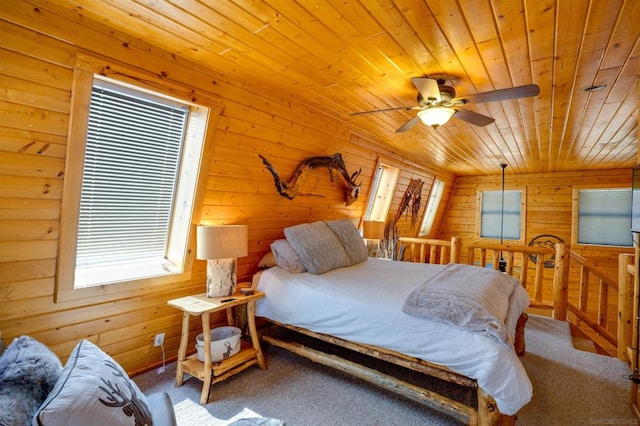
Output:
[{"xmin": 467, "ymin": 243, "xmax": 569, "ymax": 321}]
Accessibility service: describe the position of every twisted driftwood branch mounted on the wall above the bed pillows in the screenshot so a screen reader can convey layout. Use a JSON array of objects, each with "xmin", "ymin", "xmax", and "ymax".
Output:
[{"xmin": 258, "ymin": 153, "xmax": 362, "ymax": 206}]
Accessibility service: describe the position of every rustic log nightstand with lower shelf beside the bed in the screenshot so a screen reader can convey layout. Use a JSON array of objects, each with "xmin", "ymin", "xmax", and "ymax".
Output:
[{"xmin": 167, "ymin": 291, "xmax": 267, "ymax": 404}]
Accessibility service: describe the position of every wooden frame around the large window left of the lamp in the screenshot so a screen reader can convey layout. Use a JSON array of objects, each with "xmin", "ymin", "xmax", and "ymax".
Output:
[{"xmin": 54, "ymin": 54, "xmax": 221, "ymax": 305}]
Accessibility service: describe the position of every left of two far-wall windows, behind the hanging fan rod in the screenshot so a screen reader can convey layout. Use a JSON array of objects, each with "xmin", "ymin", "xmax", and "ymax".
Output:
[{"xmin": 480, "ymin": 190, "xmax": 522, "ymax": 240}]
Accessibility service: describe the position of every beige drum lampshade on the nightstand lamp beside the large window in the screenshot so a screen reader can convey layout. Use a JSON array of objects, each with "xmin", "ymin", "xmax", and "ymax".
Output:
[{"xmin": 196, "ymin": 225, "xmax": 249, "ymax": 259}]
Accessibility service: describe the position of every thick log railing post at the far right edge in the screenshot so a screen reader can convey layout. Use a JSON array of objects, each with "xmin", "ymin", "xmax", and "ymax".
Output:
[{"xmin": 617, "ymin": 253, "xmax": 634, "ymax": 362}]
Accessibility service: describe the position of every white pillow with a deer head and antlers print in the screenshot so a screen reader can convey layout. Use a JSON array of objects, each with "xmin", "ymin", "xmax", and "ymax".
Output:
[{"xmin": 33, "ymin": 340, "xmax": 151, "ymax": 426}]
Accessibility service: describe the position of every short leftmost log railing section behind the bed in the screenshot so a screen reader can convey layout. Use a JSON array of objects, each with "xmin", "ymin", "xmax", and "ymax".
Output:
[{"xmin": 398, "ymin": 237, "xmax": 461, "ymax": 265}]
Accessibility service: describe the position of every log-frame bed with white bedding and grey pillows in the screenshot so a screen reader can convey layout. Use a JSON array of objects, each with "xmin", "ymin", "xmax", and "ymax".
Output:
[{"xmin": 253, "ymin": 221, "xmax": 564, "ymax": 424}]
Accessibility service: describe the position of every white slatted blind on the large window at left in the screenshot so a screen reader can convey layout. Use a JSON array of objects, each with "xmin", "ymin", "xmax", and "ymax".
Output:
[{"xmin": 76, "ymin": 80, "xmax": 188, "ymax": 268}]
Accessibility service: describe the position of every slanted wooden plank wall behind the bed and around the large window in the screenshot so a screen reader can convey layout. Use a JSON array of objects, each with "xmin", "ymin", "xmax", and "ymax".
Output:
[{"xmin": 0, "ymin": 1, "xmax": 454, "ymax": 372}]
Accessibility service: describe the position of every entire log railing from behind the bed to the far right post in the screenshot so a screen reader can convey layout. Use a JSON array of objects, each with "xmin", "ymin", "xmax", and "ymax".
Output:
[{"xmin": 398, "ymin": 237, "xmax": 638, "ymax": 361}]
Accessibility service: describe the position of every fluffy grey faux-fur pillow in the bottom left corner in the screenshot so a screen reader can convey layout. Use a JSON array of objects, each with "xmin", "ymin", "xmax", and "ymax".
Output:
[{"xmin": 0, "ymin": 336, "xmax": 62, "ymax": 426}]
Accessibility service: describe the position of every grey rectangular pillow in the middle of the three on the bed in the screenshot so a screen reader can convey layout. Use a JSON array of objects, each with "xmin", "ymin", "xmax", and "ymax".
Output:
[{"xmin": 284, "ymin": 221, "xmax": 350, "ymax": 275}]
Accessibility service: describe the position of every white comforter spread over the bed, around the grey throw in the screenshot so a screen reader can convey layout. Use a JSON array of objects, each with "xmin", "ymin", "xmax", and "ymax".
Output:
[{"xmin": 257, "ymin": 258, "xmax": 532, "ymax": 415}]
